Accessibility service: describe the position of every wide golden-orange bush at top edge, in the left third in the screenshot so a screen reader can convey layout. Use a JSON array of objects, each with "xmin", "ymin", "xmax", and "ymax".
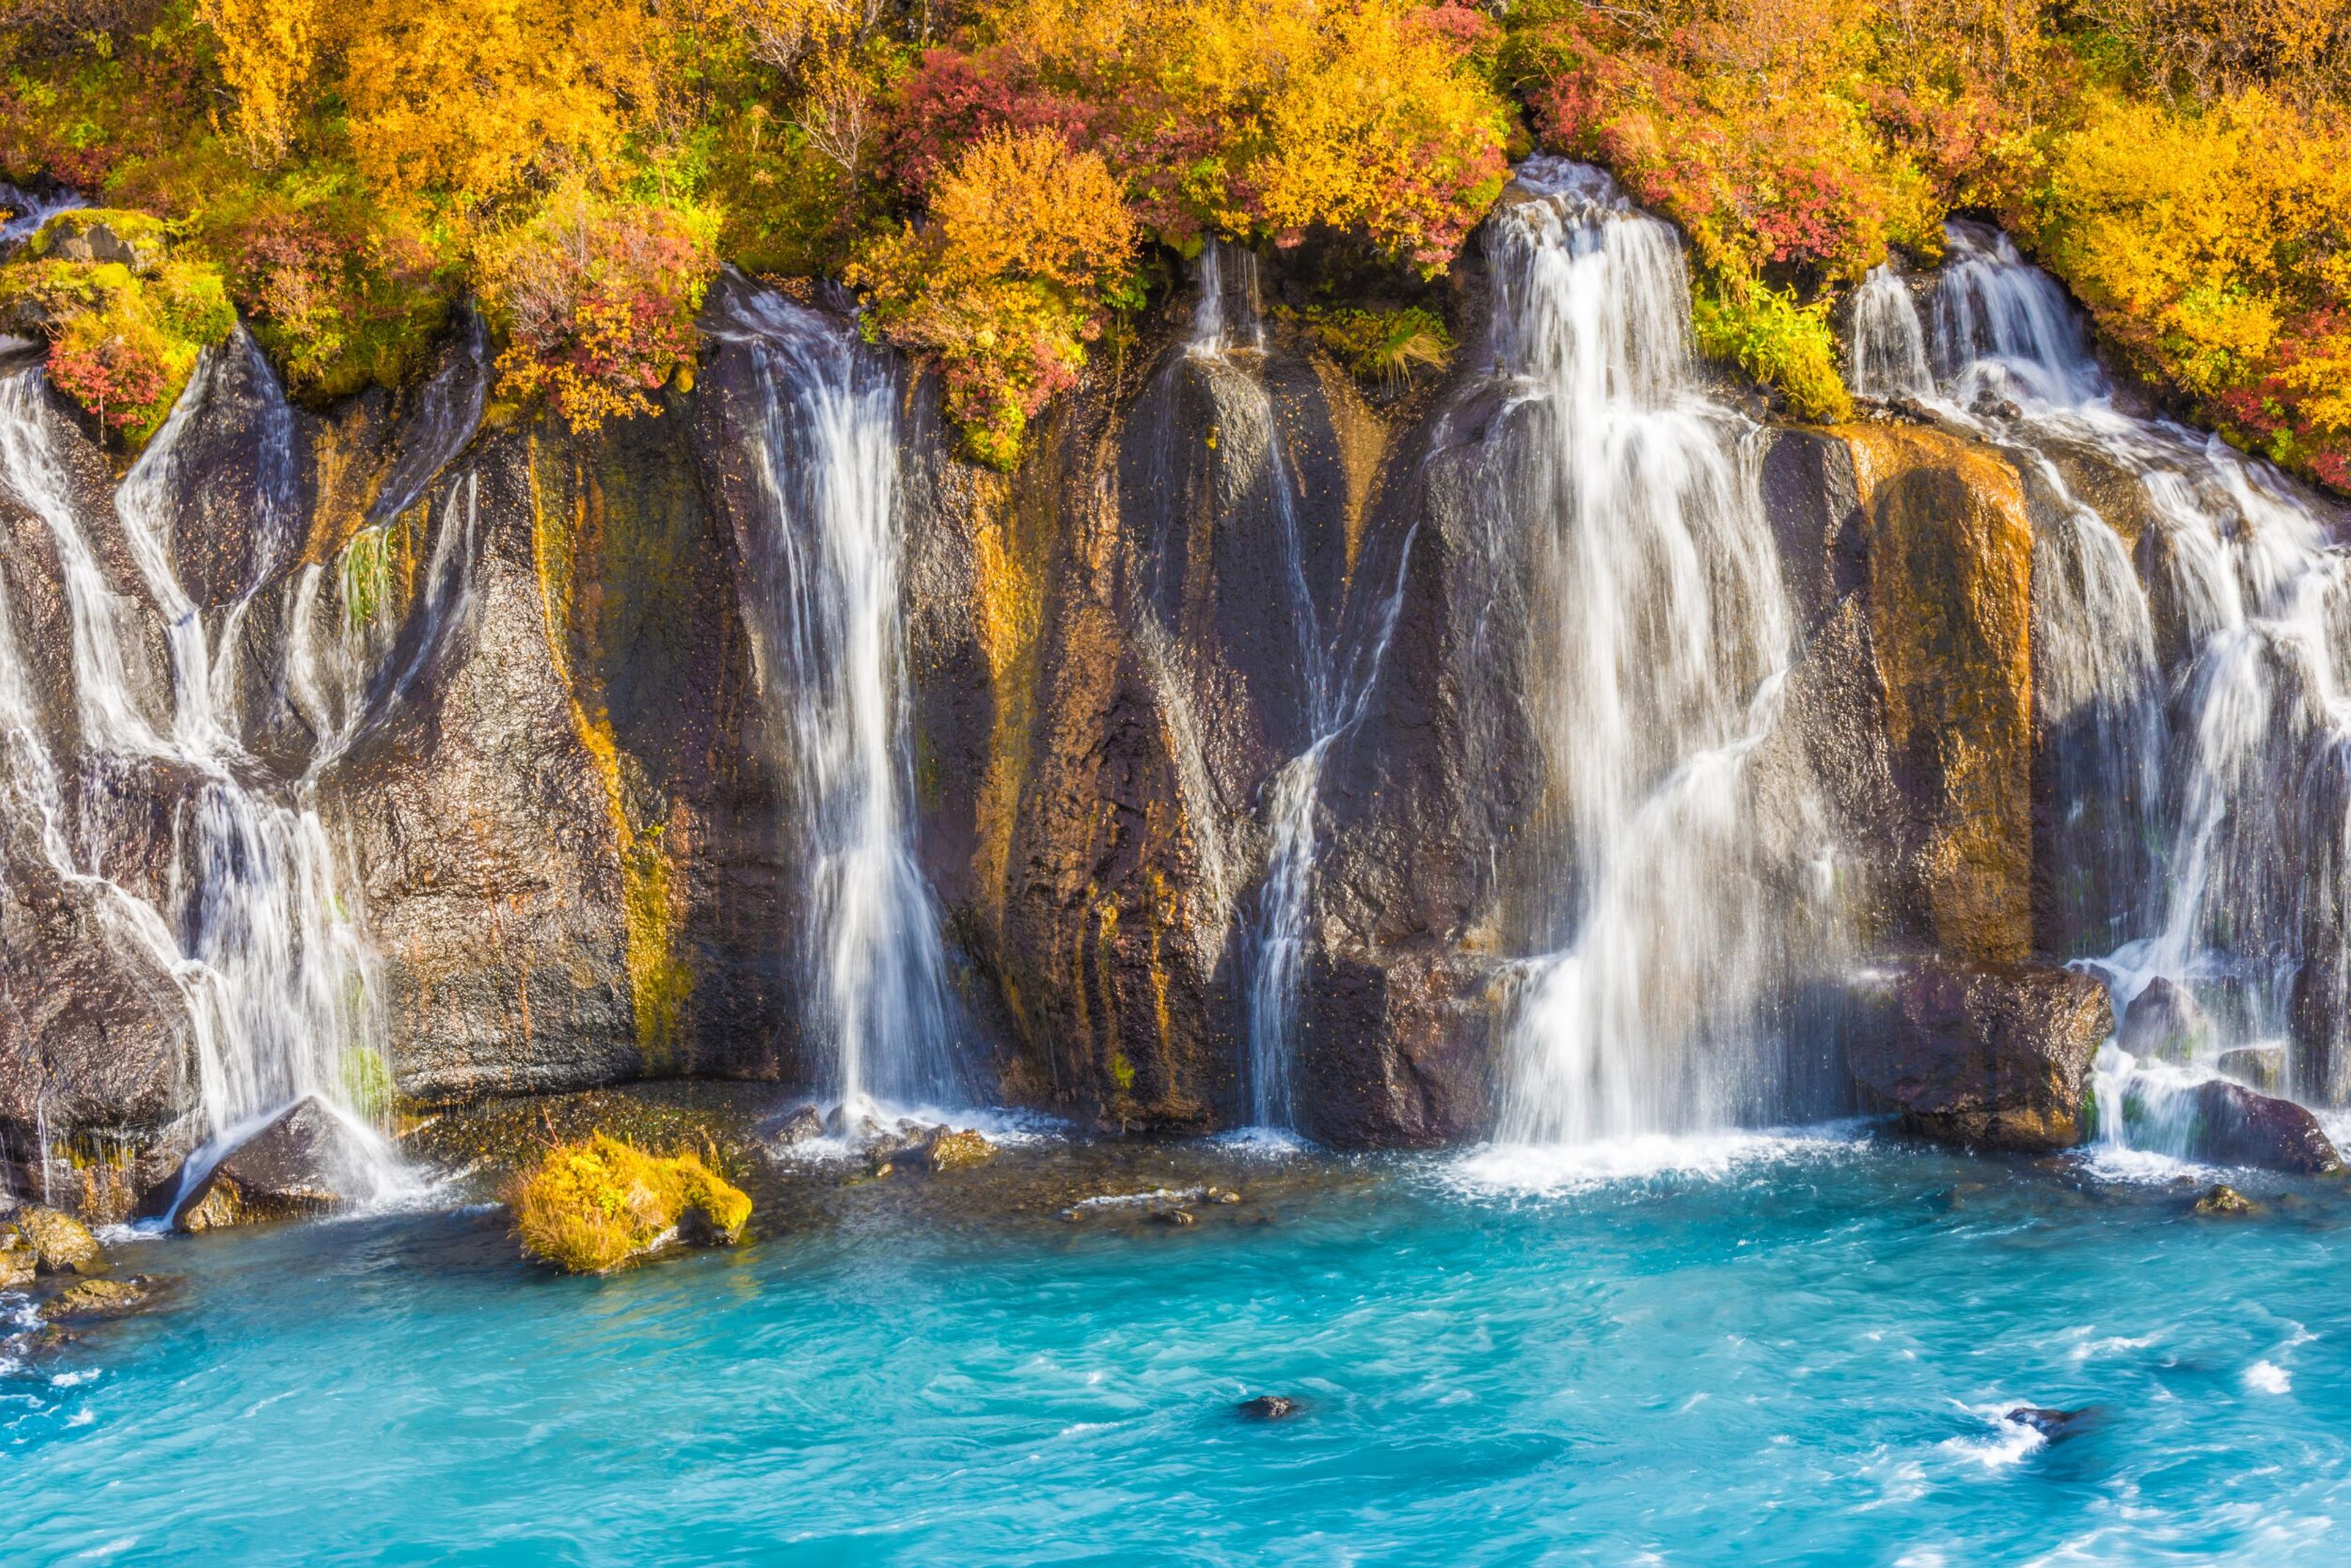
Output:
[{"xmin": 329, "ymin": 0, "xmax": 661, "ymax": 207}]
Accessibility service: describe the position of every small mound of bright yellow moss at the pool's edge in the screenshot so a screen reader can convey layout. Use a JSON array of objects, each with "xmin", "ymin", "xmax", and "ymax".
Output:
[{"xmin": 510, "ymin": 1133, "xmax": 750, "ymax": 1274}]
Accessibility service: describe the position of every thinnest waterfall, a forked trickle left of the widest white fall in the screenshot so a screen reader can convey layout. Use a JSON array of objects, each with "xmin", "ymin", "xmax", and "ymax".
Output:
[{"xmin": 1185, "ymin": 240, "xmax": 1411, "ymax": 1131}]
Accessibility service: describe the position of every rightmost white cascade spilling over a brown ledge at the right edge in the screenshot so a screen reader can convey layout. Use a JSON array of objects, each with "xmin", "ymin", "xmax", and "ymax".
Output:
[{"xmin": 1855, "ymin": 223, "xmax": 2351, "ymax": 1152}]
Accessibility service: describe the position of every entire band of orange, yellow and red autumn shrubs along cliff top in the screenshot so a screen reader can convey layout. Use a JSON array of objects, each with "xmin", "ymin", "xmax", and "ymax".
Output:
[{"xmin": 0, "ymin": 0, "xmax": 2351, "ymax": 487}]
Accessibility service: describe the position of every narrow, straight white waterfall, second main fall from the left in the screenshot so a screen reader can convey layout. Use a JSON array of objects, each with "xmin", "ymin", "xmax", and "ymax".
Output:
[{"xmin": 719, "ymin": 294, "xmax": 962, "ymax": 1109}]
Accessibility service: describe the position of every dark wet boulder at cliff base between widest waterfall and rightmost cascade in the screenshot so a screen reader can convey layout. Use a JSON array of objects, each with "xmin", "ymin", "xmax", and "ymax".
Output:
[{"xmin": 1850, "ymin": 964, "xmax": 2111, "ymax": 1154}]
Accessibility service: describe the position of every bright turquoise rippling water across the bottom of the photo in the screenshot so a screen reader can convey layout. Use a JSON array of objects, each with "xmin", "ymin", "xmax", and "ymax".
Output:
[{"xmin": 0, "ymin": 1128, "xmax": 2351, "ymax": 1568}]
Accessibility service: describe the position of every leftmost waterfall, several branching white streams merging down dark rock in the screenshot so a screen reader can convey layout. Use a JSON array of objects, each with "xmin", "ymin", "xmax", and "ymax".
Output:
[{"xmin": 0, "ymin": 359, "xmax": 400, "ymax": 1201}]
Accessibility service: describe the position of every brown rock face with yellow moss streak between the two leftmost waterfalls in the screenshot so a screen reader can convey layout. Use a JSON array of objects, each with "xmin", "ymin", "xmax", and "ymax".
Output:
[{"xmin": 322, "ymin": 409, "xmax": 792, "ymax": 1098}]
